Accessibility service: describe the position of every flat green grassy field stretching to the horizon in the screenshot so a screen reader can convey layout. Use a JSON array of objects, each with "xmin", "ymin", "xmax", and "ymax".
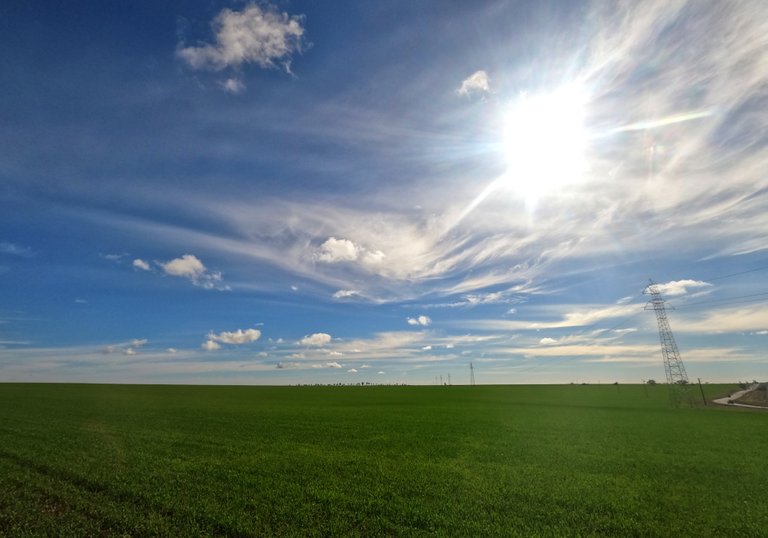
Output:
[{"xmin": 0, "ymin": 384, "xmax": 768, "ymax": 537}]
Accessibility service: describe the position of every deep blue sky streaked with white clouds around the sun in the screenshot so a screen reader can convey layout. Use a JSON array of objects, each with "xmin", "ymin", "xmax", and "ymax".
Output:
[{"xmin": 0, "ymin": 1, "xmax": 768, "ymax": 384}]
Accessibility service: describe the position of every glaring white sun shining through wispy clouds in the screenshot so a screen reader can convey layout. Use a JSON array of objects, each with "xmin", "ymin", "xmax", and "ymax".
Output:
[{"xmin": 504, "ymin": 86, "xmax": 587, "ymax": 206}]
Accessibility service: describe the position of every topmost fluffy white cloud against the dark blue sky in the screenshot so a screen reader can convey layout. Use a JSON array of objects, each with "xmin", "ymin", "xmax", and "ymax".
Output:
[{"xmin": 178, "ymin": 4, "xmax": 304, "ymax": 72}]
